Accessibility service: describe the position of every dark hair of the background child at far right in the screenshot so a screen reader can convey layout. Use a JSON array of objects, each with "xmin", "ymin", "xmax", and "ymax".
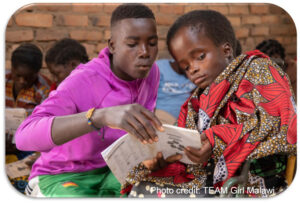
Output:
[{"xmin": 256, "ymin": 39, "xmax": 285, "ymax": 59}]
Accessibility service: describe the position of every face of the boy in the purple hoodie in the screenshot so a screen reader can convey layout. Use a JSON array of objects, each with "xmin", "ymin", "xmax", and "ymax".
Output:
[{"xmin": 108, "ymin": 18, "xmax": 158, "ymax": 81}]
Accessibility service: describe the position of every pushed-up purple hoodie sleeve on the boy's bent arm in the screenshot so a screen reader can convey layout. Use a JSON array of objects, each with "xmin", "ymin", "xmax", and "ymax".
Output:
[{"xmin": 15, "ymin": 68, "xmax": 99, "ymax": 152}]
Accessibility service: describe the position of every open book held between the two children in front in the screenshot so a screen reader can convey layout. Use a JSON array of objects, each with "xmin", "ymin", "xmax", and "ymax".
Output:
[{"xmin": 101, "ymin": 124, "xmax": 201, "ymax": 184}]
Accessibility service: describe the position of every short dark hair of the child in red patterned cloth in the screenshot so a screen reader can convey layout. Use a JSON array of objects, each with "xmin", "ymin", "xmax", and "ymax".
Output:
[{"xmin": 167, "ymin": 10, "xmax": 236, "ymax": 55}]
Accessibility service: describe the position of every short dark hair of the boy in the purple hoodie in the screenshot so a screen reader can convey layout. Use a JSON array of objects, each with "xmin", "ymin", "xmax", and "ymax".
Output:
[{"xmin": 110, "ymin": 3, "xmax": 155, "ymax": 27}]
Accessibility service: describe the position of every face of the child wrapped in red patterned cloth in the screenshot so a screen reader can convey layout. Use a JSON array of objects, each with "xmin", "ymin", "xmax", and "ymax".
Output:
[{"xmin": 169, "ymin": 27, "xmax": 233, "ymax": 89}]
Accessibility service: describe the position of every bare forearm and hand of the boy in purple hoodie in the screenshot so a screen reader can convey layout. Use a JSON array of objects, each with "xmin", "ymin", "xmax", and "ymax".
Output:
[{"xmin": 52, "ymin": 104, "xmax": 163, "ymax": 145}]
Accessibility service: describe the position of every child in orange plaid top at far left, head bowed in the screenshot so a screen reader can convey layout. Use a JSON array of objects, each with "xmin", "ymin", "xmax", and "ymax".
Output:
[{"xmin": 5, "ymin": 43, "xmax": 51, "ymax": 193}]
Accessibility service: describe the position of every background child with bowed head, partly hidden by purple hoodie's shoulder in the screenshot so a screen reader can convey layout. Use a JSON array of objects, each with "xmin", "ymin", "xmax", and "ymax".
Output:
[{"xmin": 45, "ymin": 38, "xmax": 89, "ymax": 90}]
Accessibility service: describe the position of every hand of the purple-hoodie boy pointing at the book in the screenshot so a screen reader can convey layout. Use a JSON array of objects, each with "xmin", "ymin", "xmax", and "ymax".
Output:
[{"xmin": 103, "ymin": 104, "xmax": 164, "ymax": 144}]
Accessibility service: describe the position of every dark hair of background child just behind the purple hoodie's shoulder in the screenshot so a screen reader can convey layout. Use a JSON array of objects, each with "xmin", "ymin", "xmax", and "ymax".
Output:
[{"xmin": 45, "ymin": 38, "xmax": 89, "ymax": 65}]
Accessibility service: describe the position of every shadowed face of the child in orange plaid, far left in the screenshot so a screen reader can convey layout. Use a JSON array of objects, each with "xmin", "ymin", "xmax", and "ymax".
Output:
[{"xmin": 11, "ymin": 65, "xmax": 38, "ymax": 91}]
